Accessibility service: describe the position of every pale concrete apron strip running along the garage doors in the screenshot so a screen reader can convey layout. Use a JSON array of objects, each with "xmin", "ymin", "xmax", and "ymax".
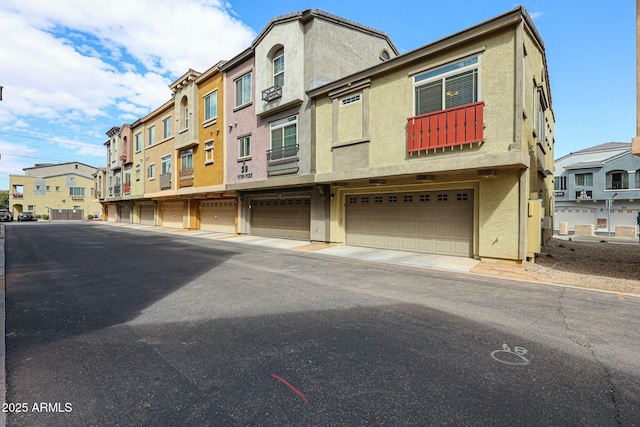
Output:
[{"xmin": 91, "ymin": 221, "xmax": 480, "ymax": 272}]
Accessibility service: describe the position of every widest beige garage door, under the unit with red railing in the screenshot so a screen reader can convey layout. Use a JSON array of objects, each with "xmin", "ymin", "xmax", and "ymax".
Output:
[{"xmin": 346, "ymin": 190, "xmax": 473, "ymax": 257}]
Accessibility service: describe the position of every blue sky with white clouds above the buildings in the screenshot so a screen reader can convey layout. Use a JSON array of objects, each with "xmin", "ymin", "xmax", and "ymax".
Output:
[{"xmin": 0, "ymin": 0, "xmax": 636, "ymax": 190}]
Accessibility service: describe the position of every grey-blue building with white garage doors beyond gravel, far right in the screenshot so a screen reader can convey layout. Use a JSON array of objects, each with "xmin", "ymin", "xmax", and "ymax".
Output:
[{"xmin": 554, "ymin": 142, "xmax": 640, "ymax": 233}]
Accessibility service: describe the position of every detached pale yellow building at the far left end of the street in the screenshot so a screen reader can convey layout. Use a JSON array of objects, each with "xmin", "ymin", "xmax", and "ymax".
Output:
[{"xmin": 9, "ymin": 162, "xmax": 101, "ymax": 219}]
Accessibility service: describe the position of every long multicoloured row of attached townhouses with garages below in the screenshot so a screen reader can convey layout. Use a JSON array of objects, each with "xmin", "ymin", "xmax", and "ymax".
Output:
[{"xmin": 95, "ymin": 7, "xmax": 555, "ymax": 262}]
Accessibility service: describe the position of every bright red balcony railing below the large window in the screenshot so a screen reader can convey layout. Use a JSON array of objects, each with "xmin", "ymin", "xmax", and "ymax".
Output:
[{"xmin": 407, "ymin": 102, "xmax": 484, "ymax": 153}]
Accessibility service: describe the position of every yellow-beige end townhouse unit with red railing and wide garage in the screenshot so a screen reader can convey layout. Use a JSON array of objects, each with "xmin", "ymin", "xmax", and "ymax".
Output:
[{"xmin": 309, "ymin": 7, "xmax": 555, "ymax": 262}]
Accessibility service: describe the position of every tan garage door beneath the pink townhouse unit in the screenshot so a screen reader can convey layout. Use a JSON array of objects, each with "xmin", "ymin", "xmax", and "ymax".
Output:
[{"xmin": 251, "ymin": 197, "xmax": 311, "ymax": 240}]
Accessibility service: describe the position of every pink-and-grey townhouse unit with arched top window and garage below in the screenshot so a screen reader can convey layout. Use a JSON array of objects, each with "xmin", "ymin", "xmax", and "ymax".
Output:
[{"xmin": 221, "ymin": 9, "xmax": 398, "ymax": 241}]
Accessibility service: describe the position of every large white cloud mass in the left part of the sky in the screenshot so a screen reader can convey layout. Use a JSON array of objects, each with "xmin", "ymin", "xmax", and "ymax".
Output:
[{"xmin": 0, "ymin": 0, "xmax": 255, "ymax": 171}]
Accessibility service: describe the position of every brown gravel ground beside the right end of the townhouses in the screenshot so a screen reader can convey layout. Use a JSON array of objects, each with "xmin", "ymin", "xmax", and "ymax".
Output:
[{"xmin": 471, "ymin": 238, "xmax": 640, "ymax": 295}]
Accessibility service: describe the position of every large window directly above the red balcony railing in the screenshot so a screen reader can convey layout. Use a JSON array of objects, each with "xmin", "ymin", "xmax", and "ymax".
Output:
[{"xmin": 414, "ymin": 56, "xmax": 480, "ymax": 116}]
